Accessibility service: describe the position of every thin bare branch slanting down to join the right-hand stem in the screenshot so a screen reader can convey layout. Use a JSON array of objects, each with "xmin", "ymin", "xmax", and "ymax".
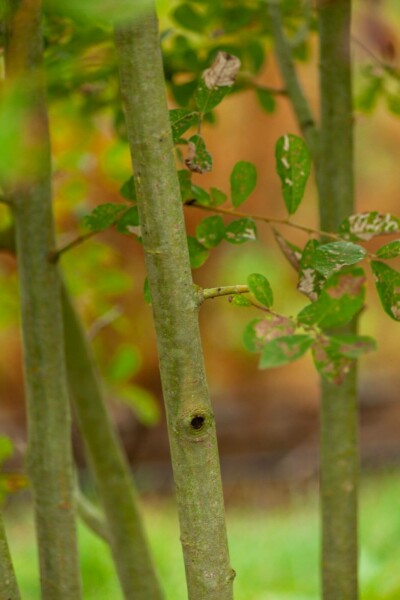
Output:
[{"xmin": 269, "ymin": 1, "xmax": 319, "ymax": 161}]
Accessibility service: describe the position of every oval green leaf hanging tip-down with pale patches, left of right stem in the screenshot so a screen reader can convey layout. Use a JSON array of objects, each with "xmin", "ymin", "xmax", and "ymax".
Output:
[{"xmin": 275, "ymin": 133, "xmax": 311, "ymax": 215}]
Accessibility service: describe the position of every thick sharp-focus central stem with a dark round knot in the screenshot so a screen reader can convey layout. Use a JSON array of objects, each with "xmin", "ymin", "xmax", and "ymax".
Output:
[{"xmin": 115, "ymin": 5, "xmax": 234, "ymax": 600}]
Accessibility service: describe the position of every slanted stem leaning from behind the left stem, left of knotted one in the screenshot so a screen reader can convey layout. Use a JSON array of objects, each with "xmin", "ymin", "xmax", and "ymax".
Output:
[{"xmin": 62, "ymin": 286, "xmax": 163, "ymax": 600}]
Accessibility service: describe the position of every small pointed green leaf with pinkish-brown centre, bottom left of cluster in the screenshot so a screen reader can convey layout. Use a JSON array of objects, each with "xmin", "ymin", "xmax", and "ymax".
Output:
[{"xmin": 259, "ymin": 335, "xmax": 314, "ymax": 369}]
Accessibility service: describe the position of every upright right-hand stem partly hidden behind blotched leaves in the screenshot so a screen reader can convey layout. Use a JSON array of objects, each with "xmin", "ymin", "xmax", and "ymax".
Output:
[{"xmin": 318, "ymin": 0, "xmax": 358, "ymax": 600}]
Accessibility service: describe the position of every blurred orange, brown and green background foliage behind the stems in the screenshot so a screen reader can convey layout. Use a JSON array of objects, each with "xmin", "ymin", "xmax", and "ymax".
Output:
[{"xmin": 0, "ymin": 0, "xmax": 400, "ymax": 600}]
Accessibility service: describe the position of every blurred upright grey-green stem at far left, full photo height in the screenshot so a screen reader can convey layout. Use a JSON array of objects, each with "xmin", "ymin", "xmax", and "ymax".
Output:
[{"xmin": 6, "ymin": 0, "xmax": 81, "ymax": 600}]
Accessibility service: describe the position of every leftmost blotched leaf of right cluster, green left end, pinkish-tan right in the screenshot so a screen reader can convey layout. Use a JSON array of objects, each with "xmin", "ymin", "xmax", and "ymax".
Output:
[{"xmin": 243, "ymin": 314, "xmax": 296, "ymax": 352}]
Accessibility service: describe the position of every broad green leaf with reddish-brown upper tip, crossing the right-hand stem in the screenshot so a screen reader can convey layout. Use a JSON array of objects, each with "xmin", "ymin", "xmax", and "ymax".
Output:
[{"xmin": 297, "ymin": 267, "xmax": 365, "ymax": 329}]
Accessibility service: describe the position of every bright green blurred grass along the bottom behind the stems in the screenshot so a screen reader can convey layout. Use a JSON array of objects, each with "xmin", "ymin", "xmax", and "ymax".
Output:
[{"xmin": 4, "ymin": 473, "xmax": 400, "ymax": 600}]
